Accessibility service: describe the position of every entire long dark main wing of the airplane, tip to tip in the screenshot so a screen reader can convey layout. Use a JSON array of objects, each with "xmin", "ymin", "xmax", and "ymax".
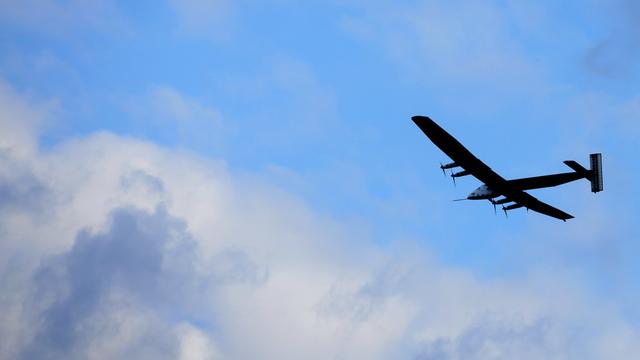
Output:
[{"xmin": 411, "ymin": 116, "xmax": 573, "ymax": 221}]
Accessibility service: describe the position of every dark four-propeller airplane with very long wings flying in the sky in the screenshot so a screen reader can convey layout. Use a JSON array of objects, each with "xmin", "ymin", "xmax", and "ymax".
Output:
[{"xmin": 411, "ymin": 116, "xmax": 603, "ymax": 222}]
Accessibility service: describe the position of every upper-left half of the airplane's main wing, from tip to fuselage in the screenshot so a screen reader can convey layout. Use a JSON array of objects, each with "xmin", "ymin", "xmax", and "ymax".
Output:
[{"xmin": 411, "ymin": 116, "xmax": 506, "ymax": 188}]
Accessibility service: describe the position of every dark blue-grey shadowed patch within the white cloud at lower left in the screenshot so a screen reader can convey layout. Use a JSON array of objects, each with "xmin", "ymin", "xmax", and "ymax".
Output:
[{"xmin": 22, "ymin": 209, "xmax": 198, "ymax": 359}]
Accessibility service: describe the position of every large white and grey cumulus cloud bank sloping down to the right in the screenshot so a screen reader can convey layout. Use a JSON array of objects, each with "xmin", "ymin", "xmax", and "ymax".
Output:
[{"xmin": 0, "ymin": 80, "xmax": 639, "ymax": 359}]
